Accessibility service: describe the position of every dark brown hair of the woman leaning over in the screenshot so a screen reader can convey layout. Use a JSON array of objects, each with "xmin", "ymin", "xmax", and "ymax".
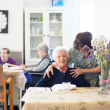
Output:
[{"xmin": 73, "ymin": 32, "xmax": 92, "ymax": 50}]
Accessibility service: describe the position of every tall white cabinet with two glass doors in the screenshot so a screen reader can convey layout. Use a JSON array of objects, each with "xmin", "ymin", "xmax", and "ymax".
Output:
[{"xmin": 25, "ymin": 7, "xmax": 66, "ymax": 64}]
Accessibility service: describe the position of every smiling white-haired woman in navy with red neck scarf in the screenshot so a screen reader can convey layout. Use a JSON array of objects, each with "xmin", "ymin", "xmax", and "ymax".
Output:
[{"xmin": 36, "ymin": 46, "xmax": 90, "ymax": 87}]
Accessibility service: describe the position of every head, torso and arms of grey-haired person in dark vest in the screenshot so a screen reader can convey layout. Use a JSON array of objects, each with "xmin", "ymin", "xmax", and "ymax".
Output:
[{"xmin": 20, "ymin": 43, "xmax": 51, "ymax": 72}]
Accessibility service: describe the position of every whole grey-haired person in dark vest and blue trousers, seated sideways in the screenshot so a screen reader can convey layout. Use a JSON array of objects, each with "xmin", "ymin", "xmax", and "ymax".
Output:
[{"xmin": 20, "ymin": 43, "xmax": 52, "ymax": 86}]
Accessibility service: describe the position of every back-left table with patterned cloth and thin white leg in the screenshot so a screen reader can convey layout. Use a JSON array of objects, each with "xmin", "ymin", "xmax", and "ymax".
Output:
[{"xmin": 3, "ymin": 69, "xmax": 27, "ymax": 110}]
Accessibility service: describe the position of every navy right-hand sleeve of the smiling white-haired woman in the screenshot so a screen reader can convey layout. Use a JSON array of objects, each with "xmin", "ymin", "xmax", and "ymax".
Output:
[{"xmin": 75, "ymin": 75, "xmax": 90, "ymax": 87}]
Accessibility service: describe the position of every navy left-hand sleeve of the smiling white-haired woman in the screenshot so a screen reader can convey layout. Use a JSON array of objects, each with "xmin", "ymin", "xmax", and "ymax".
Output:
[{"xmin": 36, "ymin": 72, "xmax": 52, "ymax": 87}]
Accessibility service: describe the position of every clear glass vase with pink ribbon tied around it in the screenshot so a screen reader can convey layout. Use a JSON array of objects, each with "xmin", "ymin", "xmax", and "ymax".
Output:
[{"xmin": 98, "ymin": 63, "xmax": 110, "ymax": 94}]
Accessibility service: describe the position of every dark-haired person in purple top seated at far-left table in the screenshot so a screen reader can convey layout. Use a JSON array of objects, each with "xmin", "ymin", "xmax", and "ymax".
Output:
[{"xmin": 0, "ymin": 48, "xmax": 20, "ymax": 110}]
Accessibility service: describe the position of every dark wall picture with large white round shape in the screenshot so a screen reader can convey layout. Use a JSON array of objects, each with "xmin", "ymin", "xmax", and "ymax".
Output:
[{"xmin": 0, "ymin": 10, "xmax": 8, "ymax": 33}]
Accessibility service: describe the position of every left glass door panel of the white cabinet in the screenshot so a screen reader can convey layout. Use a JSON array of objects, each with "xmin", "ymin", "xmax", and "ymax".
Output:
[{"xmin": 29, "ymin": 12, "xmax": 43, "ymax": 59}]
